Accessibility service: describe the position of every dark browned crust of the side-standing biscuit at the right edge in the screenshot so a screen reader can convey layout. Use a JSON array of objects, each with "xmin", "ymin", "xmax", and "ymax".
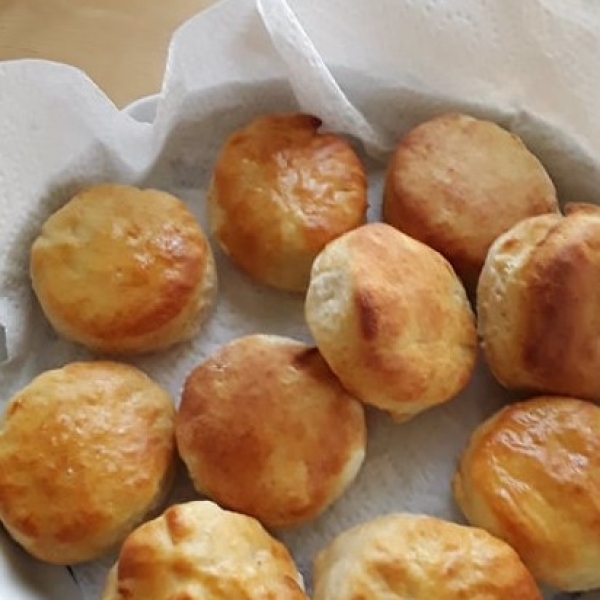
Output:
[{"xmin": 522, "ymin": 213, "xmax": 600, "ymax": 386}]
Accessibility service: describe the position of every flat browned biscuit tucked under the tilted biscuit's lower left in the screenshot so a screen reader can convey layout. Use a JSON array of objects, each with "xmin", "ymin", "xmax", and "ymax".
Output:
[{"xmin": 175, "ymin": 335, "xmax": 366, "ymax": 527}]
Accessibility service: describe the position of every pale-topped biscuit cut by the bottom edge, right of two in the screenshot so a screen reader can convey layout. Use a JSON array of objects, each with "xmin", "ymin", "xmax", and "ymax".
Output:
[{"xmin": 313, "ymin": 514, "xmax": 542, "ymax": 600}]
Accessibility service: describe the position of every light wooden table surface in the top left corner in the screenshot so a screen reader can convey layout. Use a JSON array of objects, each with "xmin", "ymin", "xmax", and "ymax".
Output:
[{"xmin": 0, "ymin": 0, "xmax": 215, "ymax": 106}]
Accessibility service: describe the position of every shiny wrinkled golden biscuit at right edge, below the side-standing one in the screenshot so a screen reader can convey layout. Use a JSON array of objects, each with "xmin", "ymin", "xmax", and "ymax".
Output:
[{"xmin": 454, "ymin": 397, "xmax": 600, "ymax": 597}]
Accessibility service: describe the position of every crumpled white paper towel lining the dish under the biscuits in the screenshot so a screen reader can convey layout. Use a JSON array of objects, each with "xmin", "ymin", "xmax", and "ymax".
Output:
[{"xmin": 0, "ymin": 0, "xmax": 600, "ymax": 600}]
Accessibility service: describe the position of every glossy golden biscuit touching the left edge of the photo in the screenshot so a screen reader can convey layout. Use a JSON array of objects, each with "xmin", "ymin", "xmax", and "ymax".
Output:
[{"xmin": 0, "ymin": 362, "xmax": 175, "ymax": 564}]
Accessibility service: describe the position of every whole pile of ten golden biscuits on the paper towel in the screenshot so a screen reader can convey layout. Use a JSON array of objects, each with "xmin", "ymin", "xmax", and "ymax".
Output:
[{"xmin": 0, "ymin": 113, "xmax": 600, "ymax": 600}]
